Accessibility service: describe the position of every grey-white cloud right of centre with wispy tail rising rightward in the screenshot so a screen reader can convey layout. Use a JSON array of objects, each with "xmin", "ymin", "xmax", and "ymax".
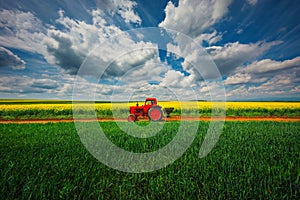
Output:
[{"xmin": 167, "ymin": 35, "xmax": 281, "ymax": 84}]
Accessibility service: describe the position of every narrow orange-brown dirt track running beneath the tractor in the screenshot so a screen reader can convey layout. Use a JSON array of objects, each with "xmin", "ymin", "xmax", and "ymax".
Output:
[{"xmin": 0, "ymin": 116, "xmax": 300, "ymax": 124}]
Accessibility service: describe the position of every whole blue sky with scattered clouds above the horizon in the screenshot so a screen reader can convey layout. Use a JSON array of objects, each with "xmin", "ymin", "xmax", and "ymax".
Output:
[{"xmin": 0, "ymin": 0, "xmax": 300, "ymax": 101}]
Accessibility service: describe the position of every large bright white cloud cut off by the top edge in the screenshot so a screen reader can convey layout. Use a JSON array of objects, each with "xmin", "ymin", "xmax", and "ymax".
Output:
[{"xmin": 159, "ymin": 0, "xmax": 231, "ymax": 38}]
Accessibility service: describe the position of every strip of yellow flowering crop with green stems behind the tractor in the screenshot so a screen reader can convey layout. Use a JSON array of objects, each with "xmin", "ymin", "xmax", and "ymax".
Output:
[{"xmin": 0, "ymin": 100, "xmax": 300, "ymax": 120}]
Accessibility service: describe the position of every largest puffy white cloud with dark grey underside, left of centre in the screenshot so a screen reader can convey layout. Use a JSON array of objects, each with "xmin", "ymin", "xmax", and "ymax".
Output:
[{"xmin": 44, "ymin": 9, "xmax": 158, "ymax": 76}]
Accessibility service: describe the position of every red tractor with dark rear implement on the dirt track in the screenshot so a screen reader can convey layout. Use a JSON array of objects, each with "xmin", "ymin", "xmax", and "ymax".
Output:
[{"xmin": 128, "ymin": 98, "xmax": 174, "ymax": 122}]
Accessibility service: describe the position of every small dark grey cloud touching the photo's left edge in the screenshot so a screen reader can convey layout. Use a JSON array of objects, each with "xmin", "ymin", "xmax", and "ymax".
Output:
[{"xmin": 0, "ymin": 47, "xmax": 26, "ymax": 69}]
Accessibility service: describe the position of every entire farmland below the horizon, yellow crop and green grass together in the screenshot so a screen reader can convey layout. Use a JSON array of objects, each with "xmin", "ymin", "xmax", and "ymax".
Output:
[{"xmin": 0, "ymin": 100, "xmax": 300, "ymax": 199}]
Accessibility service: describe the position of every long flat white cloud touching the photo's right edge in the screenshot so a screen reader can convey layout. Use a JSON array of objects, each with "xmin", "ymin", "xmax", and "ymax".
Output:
[{"xmin": 245, "ymin": 56, "xmax": 300, "ymax": 73}]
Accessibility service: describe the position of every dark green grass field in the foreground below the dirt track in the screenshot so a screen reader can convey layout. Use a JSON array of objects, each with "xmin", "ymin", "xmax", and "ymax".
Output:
[{"xmin": 0, "ymin": 122, "xmax": 300, "ymax": 199}]
